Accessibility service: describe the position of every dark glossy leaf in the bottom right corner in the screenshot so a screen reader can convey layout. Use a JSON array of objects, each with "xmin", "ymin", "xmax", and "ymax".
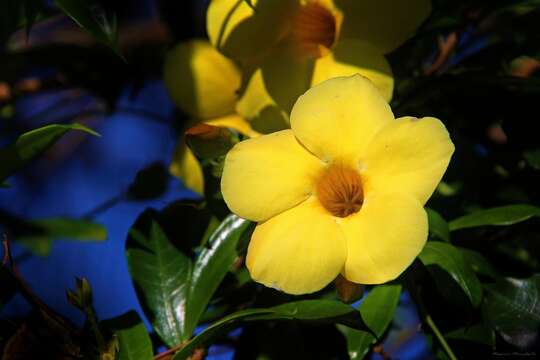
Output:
[{"xmin": 482, "ymin": 275, "xmax": 540, "ymax": 348}]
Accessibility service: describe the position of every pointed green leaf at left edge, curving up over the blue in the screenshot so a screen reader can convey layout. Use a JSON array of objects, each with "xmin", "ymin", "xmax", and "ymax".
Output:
[{"xmin": 0, "ymin": 124, "xmax": 99, "ymax": 182}]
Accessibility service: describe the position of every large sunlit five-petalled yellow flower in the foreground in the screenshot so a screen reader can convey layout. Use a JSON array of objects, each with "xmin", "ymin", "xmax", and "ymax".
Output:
[{"xmin": 221, "ymin": 75, "xmax": 454, "ymax": 294}]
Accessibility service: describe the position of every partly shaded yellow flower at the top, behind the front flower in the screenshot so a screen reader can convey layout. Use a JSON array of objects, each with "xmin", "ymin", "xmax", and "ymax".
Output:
[{"xmin": 207, "ymin": 0, "xmax": 431, "ymax": 118}]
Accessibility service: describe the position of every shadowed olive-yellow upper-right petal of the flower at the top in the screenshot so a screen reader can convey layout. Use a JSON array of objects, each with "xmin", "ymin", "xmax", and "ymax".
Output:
[{"xmin": 334, "ymin": 0, "xmax": 431, "ymax": 53}]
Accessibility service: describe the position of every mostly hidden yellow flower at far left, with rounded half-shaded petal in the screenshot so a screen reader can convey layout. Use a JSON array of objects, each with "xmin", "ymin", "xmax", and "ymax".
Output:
[{"xmin": 163, "ymin": 40, "xmax": 258, "ymax": 194}]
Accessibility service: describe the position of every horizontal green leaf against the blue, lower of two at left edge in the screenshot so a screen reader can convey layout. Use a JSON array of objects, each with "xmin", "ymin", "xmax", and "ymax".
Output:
[{"xmin": 15, "ymin": 218, "xmax": 107, "ymax": 256}]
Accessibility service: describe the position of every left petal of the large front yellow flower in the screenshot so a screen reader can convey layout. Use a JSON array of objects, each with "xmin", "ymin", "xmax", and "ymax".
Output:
[{"xmin": 221, "ymin": 130, "xmax": 322, "ymax": 221}]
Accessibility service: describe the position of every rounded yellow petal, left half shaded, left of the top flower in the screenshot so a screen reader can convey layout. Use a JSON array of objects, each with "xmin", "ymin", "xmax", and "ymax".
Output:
[{"xmin": 164, "ymin": 40, "xmax": 240, "ymax": 120}]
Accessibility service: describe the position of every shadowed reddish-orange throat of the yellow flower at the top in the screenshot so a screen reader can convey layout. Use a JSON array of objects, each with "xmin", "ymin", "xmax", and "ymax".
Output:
[{"xmin": 292, "ymin": 0, "xmax": 337, "ymax": 57}]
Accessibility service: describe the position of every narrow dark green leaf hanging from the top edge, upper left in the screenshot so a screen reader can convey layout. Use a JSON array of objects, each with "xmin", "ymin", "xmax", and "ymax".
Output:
[{"xmin": 54, "ymin": 0, "xmax": 125, "ymax": 61}]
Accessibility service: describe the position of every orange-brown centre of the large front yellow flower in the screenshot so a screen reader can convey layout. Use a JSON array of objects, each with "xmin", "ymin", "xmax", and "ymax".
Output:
[{"xmin": 316, "ymin": 165, "xmax": 364, "ymax": 217}]
